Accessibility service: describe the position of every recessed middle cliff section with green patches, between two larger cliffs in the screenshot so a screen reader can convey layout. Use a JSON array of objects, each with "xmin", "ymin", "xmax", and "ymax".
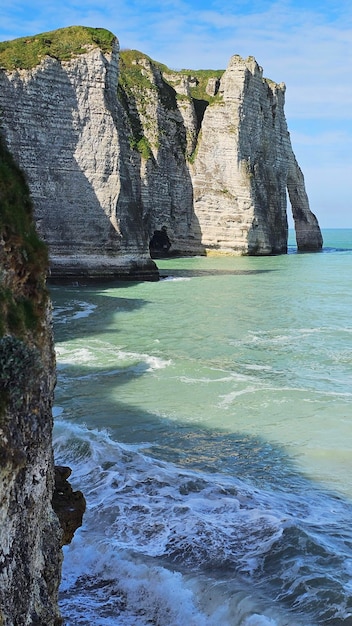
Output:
[{"xmin": 121, "ymin": 55, "xmax": 203, "ymax": 254}]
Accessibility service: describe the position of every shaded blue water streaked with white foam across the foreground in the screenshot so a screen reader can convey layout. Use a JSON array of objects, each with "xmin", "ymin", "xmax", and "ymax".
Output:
[{"xmin": 55, "ymin": 420, "xmax": 352, "ymax": 626}]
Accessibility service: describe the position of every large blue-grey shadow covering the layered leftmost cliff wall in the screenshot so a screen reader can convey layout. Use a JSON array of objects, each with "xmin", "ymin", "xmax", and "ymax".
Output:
[{"xmin": 0, "ymin": 59, "xmax": 155, "ymax": 276}]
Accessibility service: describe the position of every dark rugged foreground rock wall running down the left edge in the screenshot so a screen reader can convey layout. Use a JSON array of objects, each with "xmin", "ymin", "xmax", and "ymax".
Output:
[{"xmin": 0, "ymin": 138, "xmax": 62, "ymax": 626}]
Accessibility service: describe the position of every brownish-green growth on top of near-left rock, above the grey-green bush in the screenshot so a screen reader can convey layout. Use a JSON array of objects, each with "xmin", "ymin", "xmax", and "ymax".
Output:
[{"xmin": 0, "ymin": 136, "xmax": 48, "ymax": 338}]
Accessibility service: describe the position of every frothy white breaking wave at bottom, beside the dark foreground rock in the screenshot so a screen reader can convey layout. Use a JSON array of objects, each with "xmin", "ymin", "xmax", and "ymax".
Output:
[{"xmin": 60, "ymin": 537, "xmax": 212, "ymax": 626}]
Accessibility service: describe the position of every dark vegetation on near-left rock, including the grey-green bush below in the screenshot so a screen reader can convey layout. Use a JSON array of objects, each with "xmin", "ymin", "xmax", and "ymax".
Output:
[{"xmin": 0, "ymin": 135, "xmax": 48, "ymax": 412}]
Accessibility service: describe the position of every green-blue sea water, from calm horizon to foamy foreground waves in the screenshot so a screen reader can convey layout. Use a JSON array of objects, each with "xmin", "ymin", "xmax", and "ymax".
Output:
[{"xmin": 51, "ymin": 230, "xmax": 352, "ymax": 626}]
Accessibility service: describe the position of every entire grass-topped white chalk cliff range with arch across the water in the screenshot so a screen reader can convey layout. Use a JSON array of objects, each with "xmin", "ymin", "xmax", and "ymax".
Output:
[{"xmin": 0, "ymin": 27, "xmax": 322, "ymax": 279}]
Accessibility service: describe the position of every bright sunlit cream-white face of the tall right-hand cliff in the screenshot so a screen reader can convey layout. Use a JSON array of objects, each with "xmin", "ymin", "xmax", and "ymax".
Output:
[{"xmin": 187, "ymin": 58, "xmax": 253, "ymax": 253}]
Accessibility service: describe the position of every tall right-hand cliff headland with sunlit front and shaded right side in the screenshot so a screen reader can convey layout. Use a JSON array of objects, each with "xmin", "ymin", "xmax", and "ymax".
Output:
[{"xmin": 191, "ymin": 56, "xmax": 322, "ymax": 254}]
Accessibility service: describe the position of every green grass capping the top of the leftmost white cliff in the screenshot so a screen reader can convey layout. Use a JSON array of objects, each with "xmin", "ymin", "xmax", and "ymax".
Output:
[{"xmin": 0, "ymin": 26, "xmax": 115, "ymax": 70}]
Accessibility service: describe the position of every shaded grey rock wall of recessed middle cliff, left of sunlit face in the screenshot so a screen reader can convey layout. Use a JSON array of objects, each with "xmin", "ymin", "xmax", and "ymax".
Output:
[{"xmin": 118, "ymin": 66, "xmax": 205, "ymax": 254}]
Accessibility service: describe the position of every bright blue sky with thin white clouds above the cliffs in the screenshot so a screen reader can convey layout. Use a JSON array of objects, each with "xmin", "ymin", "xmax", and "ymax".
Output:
[{"xmin": 0, "ymin": 0, "xmax": 352, "ymax": 228}]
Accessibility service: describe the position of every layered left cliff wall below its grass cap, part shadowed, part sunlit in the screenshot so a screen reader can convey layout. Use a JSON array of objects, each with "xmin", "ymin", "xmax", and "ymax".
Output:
[{"xmin": 0, "ymin": 42, "xmax": 156, "ymax": 275}]
